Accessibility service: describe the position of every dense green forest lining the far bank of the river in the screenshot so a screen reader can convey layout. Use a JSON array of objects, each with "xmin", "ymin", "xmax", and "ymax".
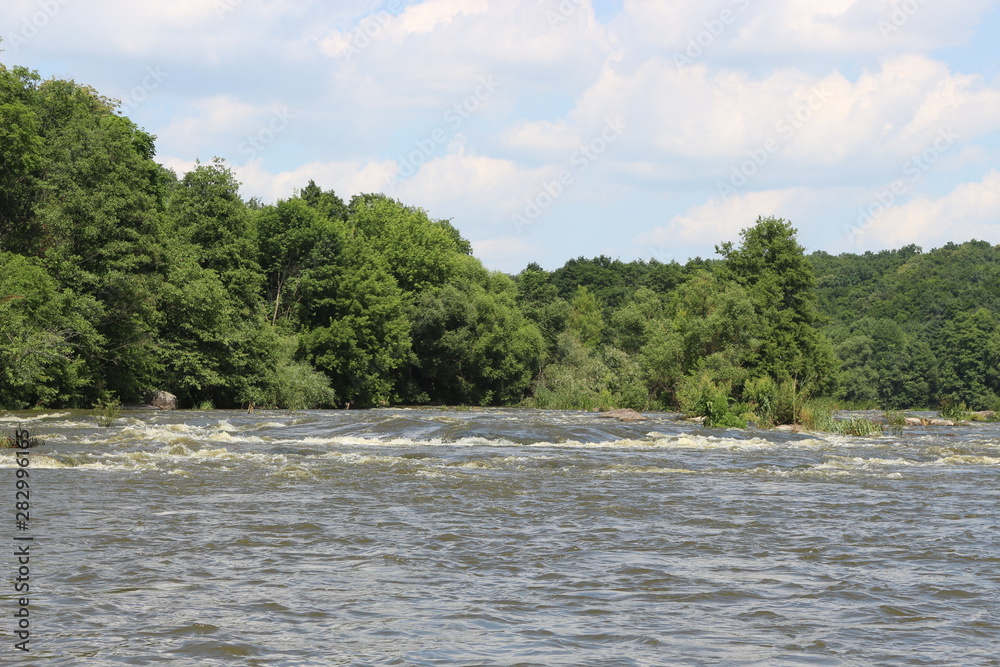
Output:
[{"xmin": 0, "ymin": 65, "xmax": 1000, "ymax": 426}]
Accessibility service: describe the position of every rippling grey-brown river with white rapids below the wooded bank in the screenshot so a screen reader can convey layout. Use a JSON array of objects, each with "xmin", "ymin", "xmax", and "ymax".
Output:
[{"xmin": 0, "ymin": 409, "xmax": 1000, "ymax": 666}]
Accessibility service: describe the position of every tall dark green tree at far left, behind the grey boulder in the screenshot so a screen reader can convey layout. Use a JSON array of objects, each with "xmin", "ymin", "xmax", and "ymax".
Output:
[{"xmin": 23, "ymin": 79, "xmax": 167, "ymax": 401}]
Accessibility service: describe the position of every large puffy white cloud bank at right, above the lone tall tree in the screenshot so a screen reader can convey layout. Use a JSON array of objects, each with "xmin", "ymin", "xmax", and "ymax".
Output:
[{"xmin": 552, "ymin": 55, "xmax": 1000, "ymax": 190}]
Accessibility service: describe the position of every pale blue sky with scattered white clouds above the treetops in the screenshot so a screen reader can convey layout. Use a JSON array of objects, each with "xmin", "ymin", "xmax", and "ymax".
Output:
[{"xmin": 0, "ymin": 0, "xmax": 1000, "ymax": 273}]
